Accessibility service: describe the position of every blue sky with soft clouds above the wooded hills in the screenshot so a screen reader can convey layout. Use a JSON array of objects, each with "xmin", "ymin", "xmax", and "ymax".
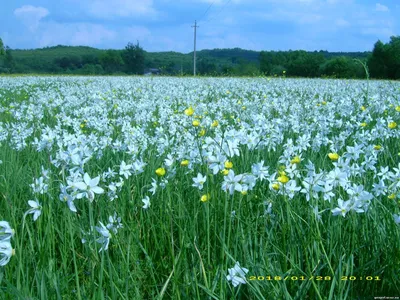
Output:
[{"xmin": 0, "ymin": 0, "xmax": 400, "ymax": 53}]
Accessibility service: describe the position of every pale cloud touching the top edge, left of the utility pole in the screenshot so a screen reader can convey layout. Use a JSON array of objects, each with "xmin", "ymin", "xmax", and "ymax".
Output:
[{"xmin": 88, "ymin": 0, "xmax": 156, "ymax": 19}]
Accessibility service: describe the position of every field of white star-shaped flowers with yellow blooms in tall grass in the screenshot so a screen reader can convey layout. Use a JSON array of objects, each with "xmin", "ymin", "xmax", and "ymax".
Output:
[{"xmin": 0, "ymin": 77, "xmax": 400, "ymax": 299}]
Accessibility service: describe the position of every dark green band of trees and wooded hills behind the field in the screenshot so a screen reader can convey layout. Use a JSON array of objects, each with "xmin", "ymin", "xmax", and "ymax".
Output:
[{"xmin": 0, "ymin": 36, "xmax": 400, "ymax": 79}]
